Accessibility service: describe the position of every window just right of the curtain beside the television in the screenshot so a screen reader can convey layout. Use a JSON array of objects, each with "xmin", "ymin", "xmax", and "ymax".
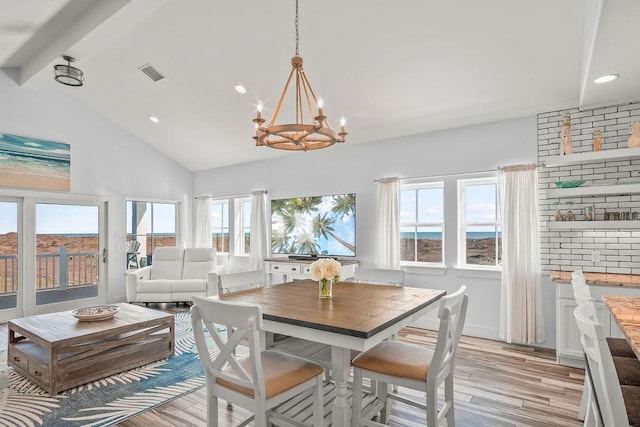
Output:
[{"xmin": 400, "ymin": 182, "xmax": 444, "ymax": 264}]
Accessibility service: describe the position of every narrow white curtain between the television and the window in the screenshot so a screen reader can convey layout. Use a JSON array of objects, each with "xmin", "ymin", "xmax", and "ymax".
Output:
[{"xmin": 375, "ymin": 178, "xmax": 400, "ymax": 269}]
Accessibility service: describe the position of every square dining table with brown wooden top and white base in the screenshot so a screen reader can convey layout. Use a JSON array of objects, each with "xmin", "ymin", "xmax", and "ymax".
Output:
[{"xmin": 212, "ymin": 280, "xmax": 446, "ymax": 427}]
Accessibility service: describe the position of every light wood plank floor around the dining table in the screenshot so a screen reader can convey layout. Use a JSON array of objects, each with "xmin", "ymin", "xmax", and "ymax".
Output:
[{"xmin": 120, "ymin": 307, "xmax": 584, "ymax": 427}]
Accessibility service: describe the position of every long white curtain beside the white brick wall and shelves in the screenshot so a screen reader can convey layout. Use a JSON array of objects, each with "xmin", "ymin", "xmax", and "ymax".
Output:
[{"xmin": 499, "ymin": 165, "xmax": 545, "ymax": 344}]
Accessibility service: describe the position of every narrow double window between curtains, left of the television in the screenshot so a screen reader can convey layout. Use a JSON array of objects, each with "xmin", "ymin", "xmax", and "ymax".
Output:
[{"xmin": 211, "ymin": 197, "xmax": 251, "ymax": 256}]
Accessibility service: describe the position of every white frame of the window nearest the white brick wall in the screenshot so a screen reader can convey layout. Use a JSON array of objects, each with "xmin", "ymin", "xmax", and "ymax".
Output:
[{"xmin": 457, "ymin": 175, "xmax": 502, "ymax": 271}]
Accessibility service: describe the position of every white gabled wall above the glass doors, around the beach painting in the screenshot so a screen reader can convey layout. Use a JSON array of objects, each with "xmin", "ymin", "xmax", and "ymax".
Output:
[{"xmin": 0, "ymin": 69, "xmax": 193, "ymax": 302}]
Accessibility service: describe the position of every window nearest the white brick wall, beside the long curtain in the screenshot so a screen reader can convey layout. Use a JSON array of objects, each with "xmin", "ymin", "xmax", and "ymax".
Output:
[{"xmin": 458, "ymin": 177, "xmax": 502, "ymax": 267}]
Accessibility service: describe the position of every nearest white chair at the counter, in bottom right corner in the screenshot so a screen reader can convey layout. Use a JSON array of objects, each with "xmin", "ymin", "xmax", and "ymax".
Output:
[{"xmin": 574, "ymin": 301, "xmax": 640, "ymax": 427}]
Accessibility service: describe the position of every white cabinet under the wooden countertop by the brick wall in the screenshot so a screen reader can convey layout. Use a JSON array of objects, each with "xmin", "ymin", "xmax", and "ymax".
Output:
[{"xmin": 555, "ymin": 282, "xmax": 640, "ymax": 367}]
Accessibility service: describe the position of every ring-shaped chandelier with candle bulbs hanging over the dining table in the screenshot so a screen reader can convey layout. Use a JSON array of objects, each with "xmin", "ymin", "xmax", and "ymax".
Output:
[{"xmin": 253, "ymin": 0, "xmax": 347, "ymax": 151}]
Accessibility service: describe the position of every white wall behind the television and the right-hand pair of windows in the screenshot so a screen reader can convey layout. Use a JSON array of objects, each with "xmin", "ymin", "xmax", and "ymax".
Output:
[{"xmin": 193, "ymin": 117, "xmax": 555, "ymax": 347}]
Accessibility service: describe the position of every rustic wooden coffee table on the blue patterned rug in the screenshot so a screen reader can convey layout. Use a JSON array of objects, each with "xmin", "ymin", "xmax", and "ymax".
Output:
[{"xmin": 7, "ymin": 304, "xmax": 175, "ymax": 395}]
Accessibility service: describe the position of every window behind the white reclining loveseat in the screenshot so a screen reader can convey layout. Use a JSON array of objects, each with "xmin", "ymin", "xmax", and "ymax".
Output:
[{"xmin": 127, "ymin": 200, "xmax": 178, "ymax": 257}]
